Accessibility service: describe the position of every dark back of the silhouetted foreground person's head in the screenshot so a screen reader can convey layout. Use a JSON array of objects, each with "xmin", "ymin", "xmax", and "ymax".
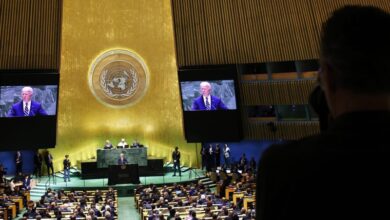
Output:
[{"xmin": 319, "ymin": 6, "xmax": 390, "ymax": 117}]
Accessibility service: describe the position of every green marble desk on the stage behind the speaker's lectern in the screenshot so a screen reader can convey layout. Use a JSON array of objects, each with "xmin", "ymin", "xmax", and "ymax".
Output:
[{"xmin": 96, "ymin": 147, "xmax": 148, "ymax": 168}]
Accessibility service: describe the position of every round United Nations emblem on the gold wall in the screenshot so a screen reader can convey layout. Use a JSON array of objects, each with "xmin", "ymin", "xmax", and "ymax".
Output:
[{"xmin": 89, "ymin": 50, "xmax": 149, "ymax": 107}]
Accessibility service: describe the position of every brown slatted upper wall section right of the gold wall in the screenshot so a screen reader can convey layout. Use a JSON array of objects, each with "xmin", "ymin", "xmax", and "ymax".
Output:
[{"xmin": 172, "ymin": 0, "xmax": 390, "ymax": 66}]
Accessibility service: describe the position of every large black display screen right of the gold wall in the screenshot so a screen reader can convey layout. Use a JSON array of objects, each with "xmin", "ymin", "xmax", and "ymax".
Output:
[{"xmin": 179, "ymin": 65, "xmax": 242, "ymax": 142}]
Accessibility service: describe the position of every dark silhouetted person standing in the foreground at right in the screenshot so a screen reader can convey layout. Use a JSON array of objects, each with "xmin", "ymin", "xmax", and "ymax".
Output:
[{"xmin": 256, "ymin": 6, "xmax": 390, "ymax": 220}]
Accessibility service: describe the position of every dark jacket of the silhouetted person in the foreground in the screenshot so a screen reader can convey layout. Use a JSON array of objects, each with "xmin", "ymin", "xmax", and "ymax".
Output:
[{"xmin": 256, "ymin": 111, "xmax": 390, "ymax": 220}]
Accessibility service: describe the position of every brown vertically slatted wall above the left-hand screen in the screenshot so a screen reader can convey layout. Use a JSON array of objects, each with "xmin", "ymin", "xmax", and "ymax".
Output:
[{"xmin": 0, "ymin": 0, "xmax": 62, "ymax": 70}]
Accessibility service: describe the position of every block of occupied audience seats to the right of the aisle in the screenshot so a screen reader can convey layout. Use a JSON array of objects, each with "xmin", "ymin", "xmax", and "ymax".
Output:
[{"xmin": 134, "ymin": 173, "xmax": 256, "ymax": 220}]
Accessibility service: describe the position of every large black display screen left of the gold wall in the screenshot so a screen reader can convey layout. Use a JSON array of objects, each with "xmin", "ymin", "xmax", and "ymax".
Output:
[{"xmin": 0, "ymin": 70, "xmax": 59, "ymax": 150}]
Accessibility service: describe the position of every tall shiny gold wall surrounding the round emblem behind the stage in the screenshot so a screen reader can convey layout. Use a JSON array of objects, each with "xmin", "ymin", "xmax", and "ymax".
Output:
[{"xmin": 51, "ymin": 0, "xmax": 198, "ymax": 170}]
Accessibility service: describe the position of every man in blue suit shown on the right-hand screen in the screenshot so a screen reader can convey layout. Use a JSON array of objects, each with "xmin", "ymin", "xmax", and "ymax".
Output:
[{"xmin": 191, "ymin": 82, "xmax": 227, "ymax": 111}]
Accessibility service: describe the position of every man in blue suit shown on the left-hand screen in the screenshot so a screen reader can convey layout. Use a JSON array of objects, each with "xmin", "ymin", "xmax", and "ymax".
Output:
[{"xmin": 8, "ymin": 86, "xmax": 47, "ymax": 117}]
